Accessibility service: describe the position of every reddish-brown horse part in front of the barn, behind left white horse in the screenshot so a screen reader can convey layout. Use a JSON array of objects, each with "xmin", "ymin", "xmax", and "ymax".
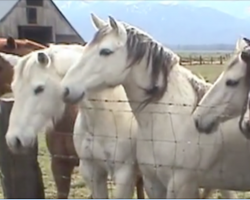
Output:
[{"xmin": 0, "ymin": 37, "xmax": 46, "ymax": 56}]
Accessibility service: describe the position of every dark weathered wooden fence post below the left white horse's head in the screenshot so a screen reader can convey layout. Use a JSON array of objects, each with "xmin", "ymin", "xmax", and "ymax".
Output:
[{"xmin": 0, "ymin": 99, "xmax": 45, "ymax": 199}]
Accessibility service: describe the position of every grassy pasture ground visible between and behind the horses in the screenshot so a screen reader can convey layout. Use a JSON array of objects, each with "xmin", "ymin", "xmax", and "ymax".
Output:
[{"xmin": 0, "ymin": 54, "xmax": 246, "ymax": 199}]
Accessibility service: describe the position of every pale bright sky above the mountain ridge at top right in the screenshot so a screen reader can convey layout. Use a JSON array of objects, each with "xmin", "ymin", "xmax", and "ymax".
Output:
[{"xmin": 55, "ymin": 0, "xmax": 250, "ymax": 18}]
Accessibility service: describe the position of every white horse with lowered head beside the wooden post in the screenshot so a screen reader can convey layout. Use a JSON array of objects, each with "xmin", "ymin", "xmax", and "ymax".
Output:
[{"xmin": 2, "ymin": 41, "xmax": 235, "ymax": 198}]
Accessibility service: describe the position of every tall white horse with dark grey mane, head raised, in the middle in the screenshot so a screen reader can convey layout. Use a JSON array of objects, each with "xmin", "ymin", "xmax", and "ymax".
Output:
[{"xmin": 61, "ymin": 15, "xmax": 250, "ymax": 198}]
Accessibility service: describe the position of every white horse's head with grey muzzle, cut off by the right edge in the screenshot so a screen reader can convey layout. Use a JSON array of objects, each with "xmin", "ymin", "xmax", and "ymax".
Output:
[{"xmin": 194, "ymin": 38, "xmax": 250, "ymax": 138}]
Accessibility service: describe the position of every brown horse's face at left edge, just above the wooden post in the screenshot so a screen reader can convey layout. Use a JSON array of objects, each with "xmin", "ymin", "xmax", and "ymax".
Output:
[{"xmin": 0, "ymin": 55, "xmax": 14, "ymax": 96}]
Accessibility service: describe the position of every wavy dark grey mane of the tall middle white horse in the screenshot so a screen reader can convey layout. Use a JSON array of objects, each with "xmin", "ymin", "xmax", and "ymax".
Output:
[{"xmin": 91, "ymin": 22, "xmax": 180, "ymax": 107}]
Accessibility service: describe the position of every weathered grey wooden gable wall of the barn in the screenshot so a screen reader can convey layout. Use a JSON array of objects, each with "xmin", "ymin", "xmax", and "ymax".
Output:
[{"xmin": 0, "ymin": 0, "xmax": 82, "ymax": 41}]
